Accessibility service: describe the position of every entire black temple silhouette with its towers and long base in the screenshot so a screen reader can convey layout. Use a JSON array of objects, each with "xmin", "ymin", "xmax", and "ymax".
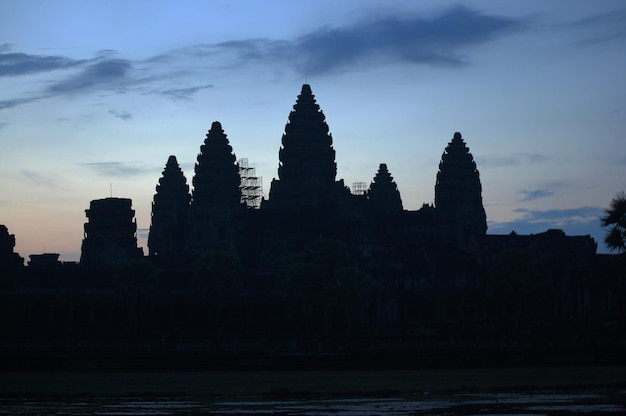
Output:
[{"xmin": 0, "ymin": 84, "xmax": 626, "ymax": 364}]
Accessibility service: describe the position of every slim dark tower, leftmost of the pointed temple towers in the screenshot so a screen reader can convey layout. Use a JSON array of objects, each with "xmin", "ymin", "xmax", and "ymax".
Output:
[{"xmin": 148, "ymin": 156, "xmax": 191, "ymax": 260}]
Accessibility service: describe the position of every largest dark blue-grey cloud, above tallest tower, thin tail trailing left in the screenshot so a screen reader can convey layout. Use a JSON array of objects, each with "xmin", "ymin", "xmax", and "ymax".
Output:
[{"xmin": 165, "ymin": 7, "xmax": 525, "ymax": 74}]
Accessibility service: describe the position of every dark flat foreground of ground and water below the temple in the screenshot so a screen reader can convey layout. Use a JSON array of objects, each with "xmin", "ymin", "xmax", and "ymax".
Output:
[{"xmin": 0, "ymin": 366, "xmax": 626, "ymax": 416}]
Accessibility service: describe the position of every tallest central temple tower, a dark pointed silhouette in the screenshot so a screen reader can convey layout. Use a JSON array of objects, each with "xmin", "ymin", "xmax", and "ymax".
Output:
[{"xmin": 262, "ymin": 84, "xmax": 349, "ymax": 212}]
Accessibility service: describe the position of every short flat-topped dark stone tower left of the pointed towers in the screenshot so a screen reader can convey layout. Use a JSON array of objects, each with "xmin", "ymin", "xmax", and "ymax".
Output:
[{"xmin": 80, "ymin": 198, "xmax": 143, "ymax": 267}]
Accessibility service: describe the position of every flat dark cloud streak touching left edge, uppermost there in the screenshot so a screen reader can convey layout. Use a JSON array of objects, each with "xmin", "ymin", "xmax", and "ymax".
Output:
[{"xmin": 0, "ymin": 50, "xmax": 84, "ymax": 77}]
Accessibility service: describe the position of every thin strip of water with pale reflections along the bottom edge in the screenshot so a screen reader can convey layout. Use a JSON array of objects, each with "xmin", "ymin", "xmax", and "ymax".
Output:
[{"xmin": 0, "ymin": 389, "xmax": 626, "ymax": 416}]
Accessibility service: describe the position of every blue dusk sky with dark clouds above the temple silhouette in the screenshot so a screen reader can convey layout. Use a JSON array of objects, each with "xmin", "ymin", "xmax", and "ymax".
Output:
[{"xmin": 0, "ymin": 0, "xmax": 626, "ymax": 261}]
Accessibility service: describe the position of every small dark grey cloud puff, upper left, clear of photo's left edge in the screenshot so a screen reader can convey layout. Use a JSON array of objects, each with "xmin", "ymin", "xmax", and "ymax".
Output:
[{"xmin": 48, "ymin": 58, "xmax": 132, "ymax": 94}]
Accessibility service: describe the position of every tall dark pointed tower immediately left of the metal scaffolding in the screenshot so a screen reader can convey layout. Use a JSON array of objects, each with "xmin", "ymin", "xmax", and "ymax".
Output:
[{"xmin": 187, "ymin": 121, "xmax": 244, "ymax": 252}]
